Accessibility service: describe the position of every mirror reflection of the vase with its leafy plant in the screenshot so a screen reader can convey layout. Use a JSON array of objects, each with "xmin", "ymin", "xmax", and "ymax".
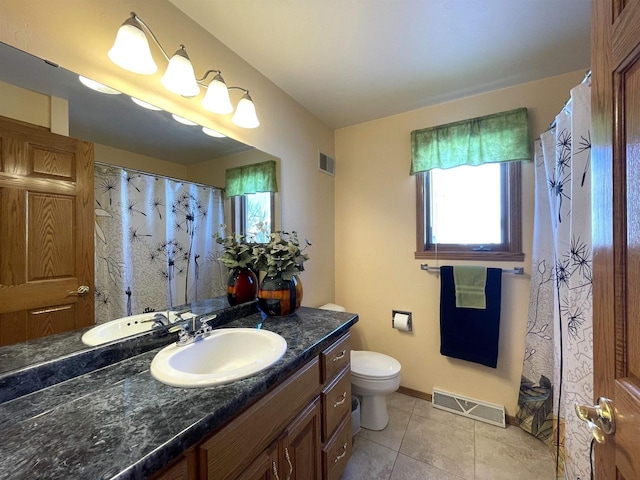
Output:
[{"xmin": 213, "ymin": 225, "xmax": 258, "ymax": 306}]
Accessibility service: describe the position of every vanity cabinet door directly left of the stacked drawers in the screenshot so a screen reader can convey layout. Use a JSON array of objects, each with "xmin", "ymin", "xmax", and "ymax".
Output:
[{"xmin": 280, "ymin": 398, "xmax": 322, "ymax": 480}]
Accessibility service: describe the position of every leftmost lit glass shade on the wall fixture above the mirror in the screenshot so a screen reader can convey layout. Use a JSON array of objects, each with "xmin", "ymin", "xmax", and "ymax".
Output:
[{"xmin": 107, "ymin": 15, "xmax": 158, "ymax": 75}]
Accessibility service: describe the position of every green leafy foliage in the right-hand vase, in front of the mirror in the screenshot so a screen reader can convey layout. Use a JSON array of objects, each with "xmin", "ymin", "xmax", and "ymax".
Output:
[{"xmin": 252, "ymin": 231, "xmax": 312, "ymax": 280}]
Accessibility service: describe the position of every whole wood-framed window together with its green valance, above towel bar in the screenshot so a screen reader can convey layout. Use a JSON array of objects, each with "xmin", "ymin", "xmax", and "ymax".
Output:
[{"xmin": 411, "ymin": 108, "xmax": 530, "ymax": 261}]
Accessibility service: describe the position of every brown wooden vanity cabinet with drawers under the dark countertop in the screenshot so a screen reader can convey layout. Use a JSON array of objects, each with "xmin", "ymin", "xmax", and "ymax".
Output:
[{"xmin": 154, "ymin": 333, "xmax": 351, "ymax": 480}]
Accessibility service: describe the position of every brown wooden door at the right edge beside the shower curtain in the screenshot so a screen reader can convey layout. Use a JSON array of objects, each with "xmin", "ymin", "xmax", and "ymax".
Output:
[{"xmin": 591, "ymin": 0, "xmax": 640, "ymax": 480}]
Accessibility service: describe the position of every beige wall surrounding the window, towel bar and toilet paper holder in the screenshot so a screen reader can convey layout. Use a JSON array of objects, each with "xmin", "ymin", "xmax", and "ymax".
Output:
[{"xmin": 335, "ymin": 70, "xmax": 584, "ymax": 415}]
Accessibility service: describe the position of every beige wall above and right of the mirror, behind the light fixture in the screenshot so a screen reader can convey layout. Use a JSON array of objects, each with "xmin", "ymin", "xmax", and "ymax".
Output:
[{"xmin": 0, "ymin": 0, "xmax": 334, "ymax": 306}]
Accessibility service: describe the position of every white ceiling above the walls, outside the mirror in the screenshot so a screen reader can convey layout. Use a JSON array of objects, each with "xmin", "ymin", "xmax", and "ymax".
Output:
[{"xmin": 170, "ymin": 0, "xmax": 591, "ymax": 128}]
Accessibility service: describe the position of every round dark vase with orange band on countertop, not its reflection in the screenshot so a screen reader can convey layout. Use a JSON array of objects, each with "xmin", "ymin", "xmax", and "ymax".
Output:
[{"xmin": 258, "ymin": 275, "xmax": 302, "ymax": 317}]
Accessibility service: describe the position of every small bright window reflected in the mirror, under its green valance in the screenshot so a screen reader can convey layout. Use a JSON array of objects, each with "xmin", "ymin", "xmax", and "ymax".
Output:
[{"xmin": 231, "ymin": 192, "xmax": 275, "ymax": 243}]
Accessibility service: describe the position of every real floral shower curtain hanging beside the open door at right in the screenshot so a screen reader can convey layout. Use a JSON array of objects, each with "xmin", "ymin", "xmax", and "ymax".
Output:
[{"xmin": 516, "ymin": 83, "xmax": 593, "ymax": 480}]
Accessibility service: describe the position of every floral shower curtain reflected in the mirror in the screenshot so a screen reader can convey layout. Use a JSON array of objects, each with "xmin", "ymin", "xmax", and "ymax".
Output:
[{"xmin": 95, "ymin": 165, "xmax": 226, "ymax": 323}]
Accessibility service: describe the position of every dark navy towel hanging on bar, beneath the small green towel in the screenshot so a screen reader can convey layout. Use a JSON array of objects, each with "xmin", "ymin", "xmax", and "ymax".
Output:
[{"xmin": 440, "ymin": 266, "xmax": 502, "ymax": 368}]
